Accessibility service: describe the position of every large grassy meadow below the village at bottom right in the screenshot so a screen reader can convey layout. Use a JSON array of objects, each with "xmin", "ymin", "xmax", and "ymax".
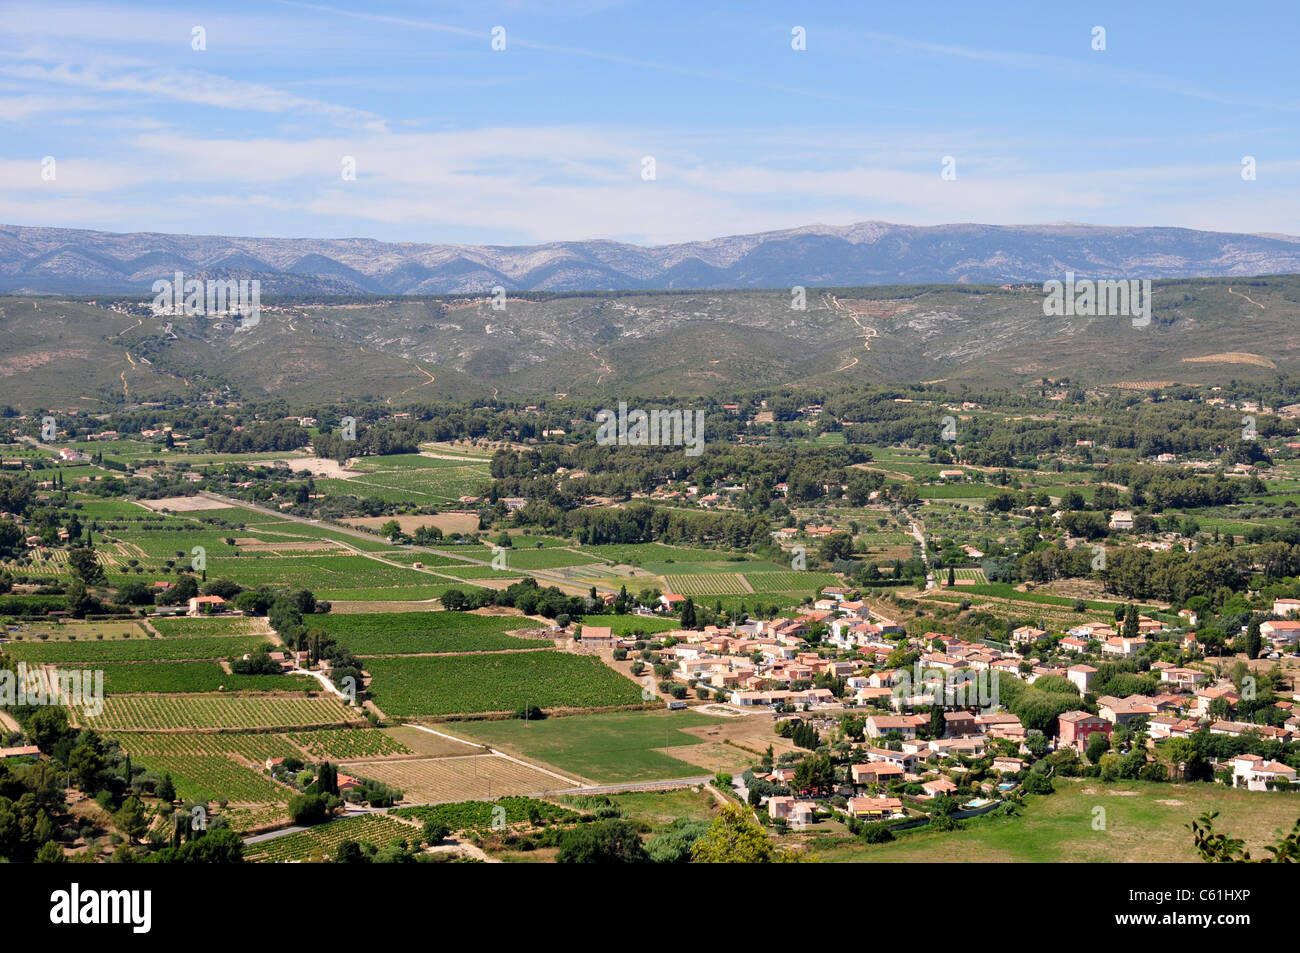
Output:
[{"xmin": 813, "ymin": 779, "xmax": 1300, "ymax": 863}]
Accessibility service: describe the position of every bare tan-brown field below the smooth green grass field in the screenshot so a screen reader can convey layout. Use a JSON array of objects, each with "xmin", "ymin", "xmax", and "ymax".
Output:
[{"xmin": 343, "ymin": 754, "xmax": 573, "ymax": 803}]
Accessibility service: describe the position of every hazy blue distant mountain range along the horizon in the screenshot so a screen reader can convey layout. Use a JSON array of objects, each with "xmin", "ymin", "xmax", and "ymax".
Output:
[{"xmin": 0, "ymin": 222, "xmax": 1300, "ymax": 295}]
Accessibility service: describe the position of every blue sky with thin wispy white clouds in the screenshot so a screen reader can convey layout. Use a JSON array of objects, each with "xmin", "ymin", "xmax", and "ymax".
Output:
[{"xmin": 0, "ymin": 0, "xmax": 1300, "ymax": 244}]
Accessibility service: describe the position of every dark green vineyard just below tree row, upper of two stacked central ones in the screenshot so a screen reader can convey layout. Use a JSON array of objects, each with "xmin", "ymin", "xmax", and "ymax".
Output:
[{"xmin": 312, "ymin": 612, "xmax": 554, "ymax": 655}]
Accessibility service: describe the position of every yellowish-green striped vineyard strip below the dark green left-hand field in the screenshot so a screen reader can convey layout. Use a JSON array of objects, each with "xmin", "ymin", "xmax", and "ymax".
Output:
[{"xmin": 72, "ymin": 694, "xmax": 360, "ymax": 732}]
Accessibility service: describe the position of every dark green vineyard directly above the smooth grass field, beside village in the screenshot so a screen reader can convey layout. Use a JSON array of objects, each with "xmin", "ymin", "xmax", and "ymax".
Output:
[{"xmin": 365, "ymin": 651, "xmax": 641, "ymax": 716}]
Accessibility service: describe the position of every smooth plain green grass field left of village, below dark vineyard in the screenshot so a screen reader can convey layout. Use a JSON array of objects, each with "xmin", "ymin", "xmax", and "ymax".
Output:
[{"xmin": 451, "ymin": 711, "xmax": 728, "ymax": 784}]
